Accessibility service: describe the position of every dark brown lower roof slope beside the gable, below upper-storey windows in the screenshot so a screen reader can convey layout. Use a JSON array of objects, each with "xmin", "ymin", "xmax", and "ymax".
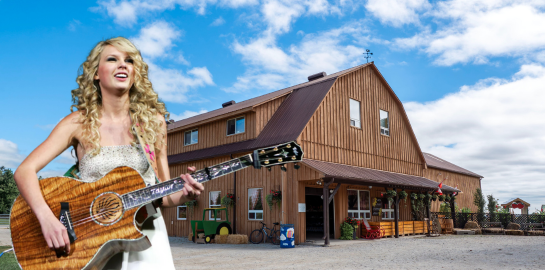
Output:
[{"xmin": 168, "ymin": 77, "xmax": 337, "ymax": 164}]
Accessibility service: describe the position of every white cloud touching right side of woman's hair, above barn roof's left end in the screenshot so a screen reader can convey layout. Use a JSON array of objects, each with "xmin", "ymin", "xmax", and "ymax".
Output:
[{"xmin": 148, "ymin": 62, "xmax": 214, "ymax": 103}]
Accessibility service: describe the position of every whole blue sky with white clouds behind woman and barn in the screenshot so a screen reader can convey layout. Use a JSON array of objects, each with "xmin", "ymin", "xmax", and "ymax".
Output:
[{"xmin": 0, "ymin": 0, "xmax": 545, "ymax": 213}]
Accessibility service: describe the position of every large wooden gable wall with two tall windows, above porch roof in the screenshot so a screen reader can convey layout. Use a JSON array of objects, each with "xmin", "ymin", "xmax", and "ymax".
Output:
[{"xmin": 299, "ymin": 68, "xmax": 423, "ymax": 176}]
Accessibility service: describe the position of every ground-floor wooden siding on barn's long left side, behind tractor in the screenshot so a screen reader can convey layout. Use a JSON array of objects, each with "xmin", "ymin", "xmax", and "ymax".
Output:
[{"xmin": 163, "ymin": 157, "xmax": 304, "ymax": 243}]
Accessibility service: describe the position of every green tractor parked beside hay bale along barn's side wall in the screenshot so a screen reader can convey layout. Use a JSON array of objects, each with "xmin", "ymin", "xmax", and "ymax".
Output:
[{"xmin": 191, "ymin": 207, "xmax": 232, "ymax": 244}]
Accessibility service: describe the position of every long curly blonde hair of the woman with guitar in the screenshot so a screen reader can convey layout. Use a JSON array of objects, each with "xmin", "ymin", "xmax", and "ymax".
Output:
[{"xmin": 70, "ymin": 37, "xmax": 170, "ymax": 155}]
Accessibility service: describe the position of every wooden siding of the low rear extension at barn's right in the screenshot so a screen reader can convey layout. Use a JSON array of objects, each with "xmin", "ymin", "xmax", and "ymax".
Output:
[{"xmin": 424, "ymin": 168, "xmax": 481, "ymax": 212}]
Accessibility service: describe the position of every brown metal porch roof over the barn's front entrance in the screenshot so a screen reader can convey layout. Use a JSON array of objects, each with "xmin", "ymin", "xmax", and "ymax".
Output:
[{"xmin": 303, "ymin": 159, "xmax": 459, "ymax": 192}]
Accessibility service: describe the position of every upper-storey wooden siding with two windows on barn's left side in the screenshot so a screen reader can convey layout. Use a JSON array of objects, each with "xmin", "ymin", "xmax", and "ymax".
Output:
[{"xmin": 168, "ymin": 96, "xmax": 286, "ymax": 155}]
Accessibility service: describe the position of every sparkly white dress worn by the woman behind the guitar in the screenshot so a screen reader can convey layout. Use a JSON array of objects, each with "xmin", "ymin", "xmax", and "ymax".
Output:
[{"xmin": 79, "ymin": 145, "xmax": 175, "ymax": 270}]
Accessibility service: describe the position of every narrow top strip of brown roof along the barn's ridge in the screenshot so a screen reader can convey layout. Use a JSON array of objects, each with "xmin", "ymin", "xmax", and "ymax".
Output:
[{"xmin": 167, "ymin": 62, "xmax": 373, "ymax": 132}]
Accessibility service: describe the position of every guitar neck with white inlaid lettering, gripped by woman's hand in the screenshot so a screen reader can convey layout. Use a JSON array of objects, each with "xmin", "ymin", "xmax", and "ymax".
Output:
[{"xmin": 121, "ymin": 155, "xmax": 253, "ymax": 210}]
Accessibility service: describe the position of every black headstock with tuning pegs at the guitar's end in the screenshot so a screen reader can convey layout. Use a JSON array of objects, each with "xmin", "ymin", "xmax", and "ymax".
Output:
[{"xmin": 253, "ymin": 142, "xmax": 303, "ymax": 168}]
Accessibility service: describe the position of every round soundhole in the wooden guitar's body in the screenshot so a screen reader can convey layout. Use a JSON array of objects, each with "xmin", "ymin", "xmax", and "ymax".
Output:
[{"xmin": 91, "ymin": 192, "xmax": 123, "ymax": 226}]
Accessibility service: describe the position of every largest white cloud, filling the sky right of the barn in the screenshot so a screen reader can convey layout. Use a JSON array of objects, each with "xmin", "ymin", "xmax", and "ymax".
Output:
[{"xmin": 405, "ymin": 64, "xmax": 545, "ymax": 210}]
